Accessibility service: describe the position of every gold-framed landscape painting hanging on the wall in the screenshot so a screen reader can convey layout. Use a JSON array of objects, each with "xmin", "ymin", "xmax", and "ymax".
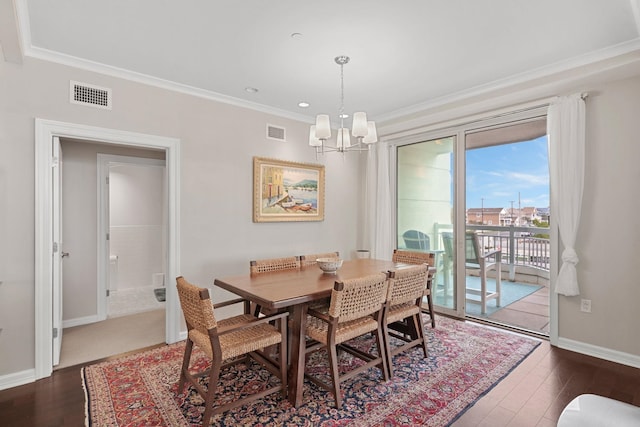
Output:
[{"xmin": 253, "ymin": 157, "xmax": 324, "ymax": 222}]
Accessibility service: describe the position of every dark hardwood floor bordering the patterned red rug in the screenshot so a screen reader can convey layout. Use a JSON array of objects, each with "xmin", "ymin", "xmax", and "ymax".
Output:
[{"xmin": 0, "ymin": 328, "xmax": 640, "ymax": 427}]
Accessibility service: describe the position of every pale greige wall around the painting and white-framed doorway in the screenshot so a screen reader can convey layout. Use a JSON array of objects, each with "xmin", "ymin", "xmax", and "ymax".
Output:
[{"xmin": 0, "ymin": 58, "xmax": 364, "ymax": 376}]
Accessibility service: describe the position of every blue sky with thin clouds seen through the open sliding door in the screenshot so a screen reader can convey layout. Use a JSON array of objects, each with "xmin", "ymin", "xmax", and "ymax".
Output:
[{"xmin": 466, "ymin": 135, "xmax": 549, "ymax": 208}]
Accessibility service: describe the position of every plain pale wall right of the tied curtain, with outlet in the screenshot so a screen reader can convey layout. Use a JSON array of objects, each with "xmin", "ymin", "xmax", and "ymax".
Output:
[{"xmin": 558, "ymin": 77, "xmax": 640, "ymax": 360}]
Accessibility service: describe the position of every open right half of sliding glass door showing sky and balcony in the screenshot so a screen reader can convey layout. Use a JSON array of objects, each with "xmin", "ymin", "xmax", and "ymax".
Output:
[{"xmin": 465, "ymin": 133, "xmax": 551, "ymax": 336}]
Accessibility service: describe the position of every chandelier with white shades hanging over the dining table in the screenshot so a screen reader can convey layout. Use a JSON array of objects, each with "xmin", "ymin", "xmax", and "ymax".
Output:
[{"xmin": 309, "ymin": 55, "xmax": 378, "ymax": 158}]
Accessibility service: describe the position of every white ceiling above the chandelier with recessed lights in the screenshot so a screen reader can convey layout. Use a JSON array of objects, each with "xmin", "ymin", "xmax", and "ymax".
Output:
[{"xmin": 15, "ymin": 0, "xmax": 640, "ymax": 121}]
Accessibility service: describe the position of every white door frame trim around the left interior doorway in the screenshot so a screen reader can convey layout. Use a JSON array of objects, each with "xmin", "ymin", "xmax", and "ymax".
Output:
[{"xmin": 34, "ymin": 118, "xmax": 180, "ymax": 380}]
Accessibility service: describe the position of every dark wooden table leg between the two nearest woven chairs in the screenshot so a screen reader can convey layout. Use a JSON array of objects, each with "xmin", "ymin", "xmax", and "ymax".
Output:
[{"xmin": 289, "ymin": 304, "xmax": 307, "ymax": 408}]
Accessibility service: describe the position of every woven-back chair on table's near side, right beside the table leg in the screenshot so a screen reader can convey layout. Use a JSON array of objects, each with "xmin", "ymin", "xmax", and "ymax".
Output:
[{"xmin": 305, "ymin": 273, "xmax": 389, "ymax": 409}]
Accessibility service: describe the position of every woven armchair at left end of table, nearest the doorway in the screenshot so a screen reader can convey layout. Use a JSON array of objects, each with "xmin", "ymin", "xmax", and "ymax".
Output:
[{"xmin": 176, "ymin": 276, "xmax": 288, "ymax": 425}]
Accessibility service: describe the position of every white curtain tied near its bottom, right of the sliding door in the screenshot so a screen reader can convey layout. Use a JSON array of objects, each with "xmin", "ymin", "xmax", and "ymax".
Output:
[{"xmin": 547, "ymin": 94, "xmax": 585, "ymax": 296}]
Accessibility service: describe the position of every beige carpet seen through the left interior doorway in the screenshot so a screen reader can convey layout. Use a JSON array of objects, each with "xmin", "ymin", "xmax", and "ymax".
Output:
[{"xmin": 54, "ymin": 309, "xmax": 165, "ymax": 369}]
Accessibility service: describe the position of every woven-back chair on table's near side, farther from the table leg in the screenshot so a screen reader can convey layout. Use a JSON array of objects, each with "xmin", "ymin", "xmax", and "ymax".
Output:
[{"xmin": 382, "ymin": 264, "xmax": 433, "ymax": 376}]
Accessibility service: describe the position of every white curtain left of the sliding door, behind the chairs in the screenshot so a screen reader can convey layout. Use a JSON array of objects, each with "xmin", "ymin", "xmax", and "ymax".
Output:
[{"xmin": 364, "ymin": 142, "xmax": 394, "ymax": 259}]
